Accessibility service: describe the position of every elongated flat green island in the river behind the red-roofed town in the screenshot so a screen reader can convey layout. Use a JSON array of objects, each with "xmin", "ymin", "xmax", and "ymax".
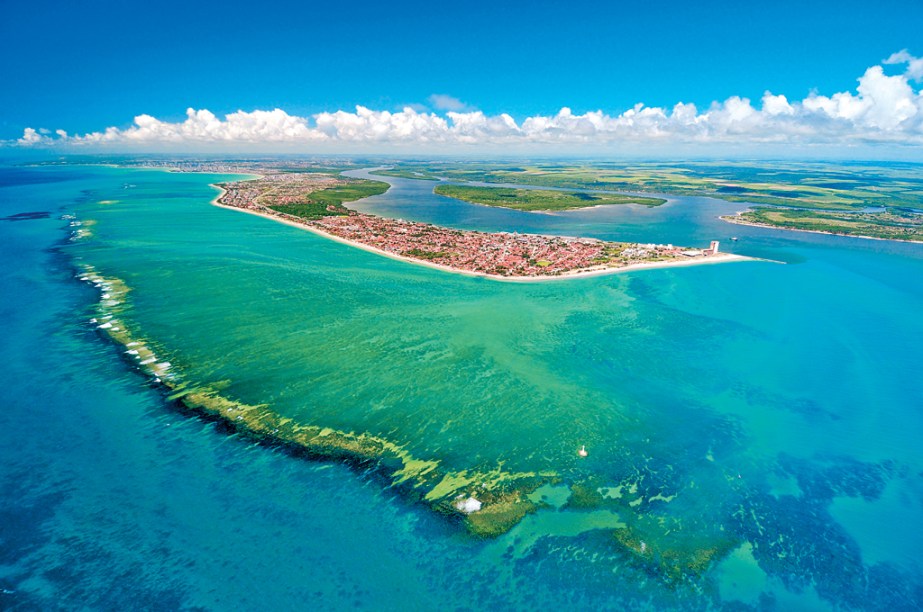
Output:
[{"xmin": 434, "ymin": 185, "xmax": 666, "ymax": 211}]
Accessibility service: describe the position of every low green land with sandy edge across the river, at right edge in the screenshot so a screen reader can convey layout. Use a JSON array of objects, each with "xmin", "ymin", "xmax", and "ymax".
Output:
[{"xmin": 725, "ymin": 207, "xmax": 923, "ymax": 242}]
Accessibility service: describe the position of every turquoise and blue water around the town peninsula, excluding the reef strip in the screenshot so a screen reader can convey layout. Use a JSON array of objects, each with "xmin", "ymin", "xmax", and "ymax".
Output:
[{"xmin": 0, "ymin": 167, "xmax": 923, "ymax": 610}]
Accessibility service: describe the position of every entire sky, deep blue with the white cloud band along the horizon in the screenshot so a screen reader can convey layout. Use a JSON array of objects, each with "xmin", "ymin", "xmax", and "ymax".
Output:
[{"xmin": 0, "ymin": 0, "xmax": 923, "ymax": 157}]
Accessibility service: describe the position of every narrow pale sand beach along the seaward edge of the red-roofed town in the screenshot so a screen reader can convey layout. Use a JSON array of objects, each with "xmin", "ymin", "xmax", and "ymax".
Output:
[{"xmin": 211, "ymin": 184, "xmax": 761, "ymax": 283}]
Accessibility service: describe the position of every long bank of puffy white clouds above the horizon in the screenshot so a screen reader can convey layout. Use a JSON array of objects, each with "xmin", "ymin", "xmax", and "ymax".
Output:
[{"xmin": 14, "ymin": 50, "xmax": 923, "ymax": 151}]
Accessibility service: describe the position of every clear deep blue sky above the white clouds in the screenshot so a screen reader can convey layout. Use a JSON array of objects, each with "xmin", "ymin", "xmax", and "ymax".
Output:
[{"xmin": 0, "ymin": 0, "xmax": 923, "ymax": 153}]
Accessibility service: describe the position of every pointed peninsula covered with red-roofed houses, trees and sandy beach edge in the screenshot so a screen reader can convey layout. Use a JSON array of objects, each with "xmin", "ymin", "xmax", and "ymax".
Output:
[{"xmin": 214, "ymin": 172, "xmax": 748, "ymax": 280}]
